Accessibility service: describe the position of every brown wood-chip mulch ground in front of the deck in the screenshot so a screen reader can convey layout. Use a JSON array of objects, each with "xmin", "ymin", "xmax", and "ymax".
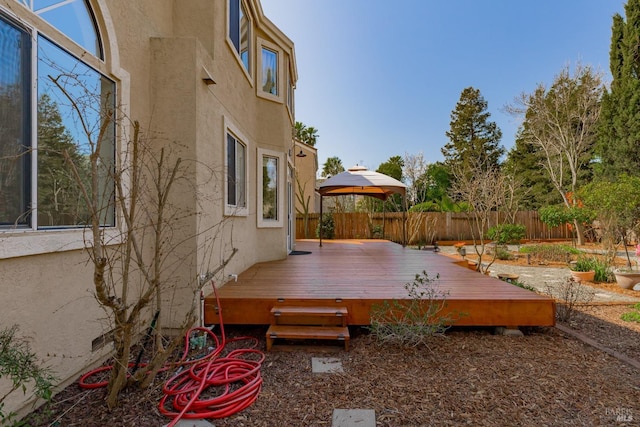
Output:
[{"xmin": 22, "ymin": 251, "xmax": 640, "ymax": 427}]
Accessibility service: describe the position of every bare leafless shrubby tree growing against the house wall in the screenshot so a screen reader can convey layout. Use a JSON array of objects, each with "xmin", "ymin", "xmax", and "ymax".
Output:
[{"xmin": 51, "ymin": 76, "xmax": 237, "ymax": 408}]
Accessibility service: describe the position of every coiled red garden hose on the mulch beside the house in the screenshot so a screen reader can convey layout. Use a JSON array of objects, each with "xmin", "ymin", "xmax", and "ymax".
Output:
[{"xmin": 79, "ymin": 282, "xmax": 265, "ymax": 427}]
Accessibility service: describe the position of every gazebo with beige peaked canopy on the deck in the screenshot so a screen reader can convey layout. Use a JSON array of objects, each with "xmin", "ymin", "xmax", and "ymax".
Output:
[{"xmin": 318, "ymin": 166, "xmax": 407, "ymax": 246}]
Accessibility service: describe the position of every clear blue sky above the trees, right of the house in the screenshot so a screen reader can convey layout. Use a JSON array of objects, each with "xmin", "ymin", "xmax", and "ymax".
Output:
[{"xmin": 261, "ymin": 0, "xmax": 626, "ymax": 174}]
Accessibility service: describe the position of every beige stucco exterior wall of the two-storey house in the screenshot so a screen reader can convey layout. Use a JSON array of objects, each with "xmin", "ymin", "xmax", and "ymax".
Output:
[{"xmin": 0, "ymin": 0, "xmax": 297, "ymax": 412}]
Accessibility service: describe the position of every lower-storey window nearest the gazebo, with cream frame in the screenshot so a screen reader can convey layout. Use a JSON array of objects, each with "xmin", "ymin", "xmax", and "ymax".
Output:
[{"xmin": 258, "ymin": 148, "xmax": 285, "ymax": 228}]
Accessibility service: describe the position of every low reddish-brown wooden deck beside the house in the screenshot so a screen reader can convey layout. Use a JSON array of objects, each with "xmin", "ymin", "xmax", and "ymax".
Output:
[{"xmin": 204, "ymin": 240, "xmax": 555, "ymax": 327}]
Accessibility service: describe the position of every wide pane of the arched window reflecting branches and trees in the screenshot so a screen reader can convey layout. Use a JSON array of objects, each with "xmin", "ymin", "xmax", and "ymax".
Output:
[{"xmin": 37, "ymin": 37, "xmax": 115, "ymax": 228}]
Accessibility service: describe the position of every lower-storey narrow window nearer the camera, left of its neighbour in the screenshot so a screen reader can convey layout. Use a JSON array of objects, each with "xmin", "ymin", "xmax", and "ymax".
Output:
[{"xmin": 225, "ymin": 133, "xmax": 247, "ymax": 215}]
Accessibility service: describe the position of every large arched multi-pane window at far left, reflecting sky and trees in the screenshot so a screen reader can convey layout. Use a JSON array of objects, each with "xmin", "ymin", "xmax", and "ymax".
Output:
[{"xmin": 0, "ymin": 0, "xmax": 116, "ymax": 229}]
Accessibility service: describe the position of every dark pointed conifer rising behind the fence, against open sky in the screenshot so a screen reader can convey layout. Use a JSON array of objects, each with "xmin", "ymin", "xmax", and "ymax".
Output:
[{"xmin": 441, "ymin": 87, "xmax": 504, "ymax": 176}]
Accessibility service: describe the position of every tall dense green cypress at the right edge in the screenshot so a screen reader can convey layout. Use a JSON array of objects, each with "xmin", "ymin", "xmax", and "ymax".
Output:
[{"xmin": 596, "ymin": 0, "xmax": 640, "ymax": 180}]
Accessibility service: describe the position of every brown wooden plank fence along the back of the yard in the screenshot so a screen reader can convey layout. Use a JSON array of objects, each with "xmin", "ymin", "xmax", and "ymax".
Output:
[{"xmin": 296, "ymin": 211, "xmax": 571, "ymax": 245}]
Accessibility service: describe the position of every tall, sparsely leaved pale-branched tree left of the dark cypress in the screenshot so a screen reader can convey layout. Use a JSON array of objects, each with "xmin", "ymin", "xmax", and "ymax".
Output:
[{"xmin": 508, "ymin": 65, "xmax": 603, "ymax": 244}]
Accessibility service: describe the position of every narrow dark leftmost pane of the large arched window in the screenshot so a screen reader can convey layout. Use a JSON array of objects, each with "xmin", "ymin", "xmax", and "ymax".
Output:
[{"xmin": 0, "ymin": 18, "xmax": 31, "ymax": 225}]
